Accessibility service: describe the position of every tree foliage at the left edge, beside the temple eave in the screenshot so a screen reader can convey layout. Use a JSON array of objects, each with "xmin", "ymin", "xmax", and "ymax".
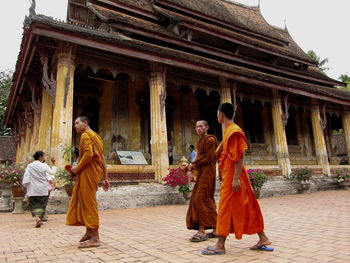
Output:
[{"xmin": 0, "ymin": 70, "xmax": 13, "ymax": 136}]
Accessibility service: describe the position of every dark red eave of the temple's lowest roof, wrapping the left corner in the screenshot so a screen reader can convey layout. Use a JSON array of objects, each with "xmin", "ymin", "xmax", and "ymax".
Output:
[{"xmin": 5, "ymin": 16, "xmax": 350, "ymax": 127}]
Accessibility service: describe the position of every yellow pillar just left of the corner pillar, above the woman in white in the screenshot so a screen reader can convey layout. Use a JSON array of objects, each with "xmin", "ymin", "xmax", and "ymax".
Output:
[{"xmin": 37, "ymin": 90, "xmax": 52, "ymax": 156}]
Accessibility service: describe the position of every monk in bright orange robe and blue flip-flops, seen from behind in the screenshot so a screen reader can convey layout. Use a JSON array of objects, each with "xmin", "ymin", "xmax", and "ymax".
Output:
[{"xmin": 201, "ymin": 103, "xmax": 273, "ymax": 255}]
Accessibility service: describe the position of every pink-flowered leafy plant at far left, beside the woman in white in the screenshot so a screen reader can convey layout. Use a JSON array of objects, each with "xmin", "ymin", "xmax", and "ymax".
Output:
[{"xmin": 0, "ymin": 162, "xmax": 24, "ymax": 185}]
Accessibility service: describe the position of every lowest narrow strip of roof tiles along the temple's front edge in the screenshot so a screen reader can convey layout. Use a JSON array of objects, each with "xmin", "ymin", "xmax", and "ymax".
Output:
[{"xmin": 26, "ymin": 16, "xmax": 350, "ymax": 100}]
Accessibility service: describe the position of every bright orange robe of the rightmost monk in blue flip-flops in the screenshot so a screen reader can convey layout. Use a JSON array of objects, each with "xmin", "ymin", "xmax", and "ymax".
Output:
[{"xmin": 216, "ymin": 123, "xmax": 264, "ymax": 239}]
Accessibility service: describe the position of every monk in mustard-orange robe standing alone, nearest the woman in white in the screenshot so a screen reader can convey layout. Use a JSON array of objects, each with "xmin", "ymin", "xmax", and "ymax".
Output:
[{"xmin": 66, "ymin": 116, "xmax": 109, "ymax": 248}]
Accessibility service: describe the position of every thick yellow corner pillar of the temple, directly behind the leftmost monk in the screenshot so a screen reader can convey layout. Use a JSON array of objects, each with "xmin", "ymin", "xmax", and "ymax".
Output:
[{"xmin": 51, "ymin": 43, "xmax": 75, "ymax": 166}]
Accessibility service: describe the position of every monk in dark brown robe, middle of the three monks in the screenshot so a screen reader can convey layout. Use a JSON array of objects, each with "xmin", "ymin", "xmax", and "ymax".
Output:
[{"xmin": 186, "ymin": 120, "xmax": 218, "ymax": 242}]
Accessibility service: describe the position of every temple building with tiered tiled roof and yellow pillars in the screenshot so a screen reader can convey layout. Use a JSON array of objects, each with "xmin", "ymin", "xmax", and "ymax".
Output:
[{"xmin": 5, "ymin": 0, "xmax": 350, "ymax": 184}]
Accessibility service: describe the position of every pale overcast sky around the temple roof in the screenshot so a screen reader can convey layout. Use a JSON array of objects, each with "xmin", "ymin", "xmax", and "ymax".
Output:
[{"xmin": 0, "ymin": 0, "xmax": 350, "ymax": 79}]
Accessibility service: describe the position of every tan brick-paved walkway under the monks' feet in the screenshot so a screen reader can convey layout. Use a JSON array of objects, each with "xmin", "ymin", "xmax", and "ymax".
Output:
[{"xmin": 0, "ymin": 190, "xmax": 350, "ymax": 263}]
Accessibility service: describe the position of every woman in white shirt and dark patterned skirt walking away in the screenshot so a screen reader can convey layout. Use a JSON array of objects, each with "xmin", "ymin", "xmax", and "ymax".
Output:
[{"xmin": 22, "ymin": 151, "xmax": 55, "ymax": 227}]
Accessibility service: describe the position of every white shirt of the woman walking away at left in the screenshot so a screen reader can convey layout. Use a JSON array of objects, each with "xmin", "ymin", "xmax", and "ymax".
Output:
[{"xmin": 22, "ymin": 161, "xmax": 55, "ymax": 196}]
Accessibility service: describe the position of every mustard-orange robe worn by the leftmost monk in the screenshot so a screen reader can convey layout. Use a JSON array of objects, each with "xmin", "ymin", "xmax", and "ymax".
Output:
[{"xmin": 66, "ymin": 130, "xmax": 104, "ymax": 228}]
